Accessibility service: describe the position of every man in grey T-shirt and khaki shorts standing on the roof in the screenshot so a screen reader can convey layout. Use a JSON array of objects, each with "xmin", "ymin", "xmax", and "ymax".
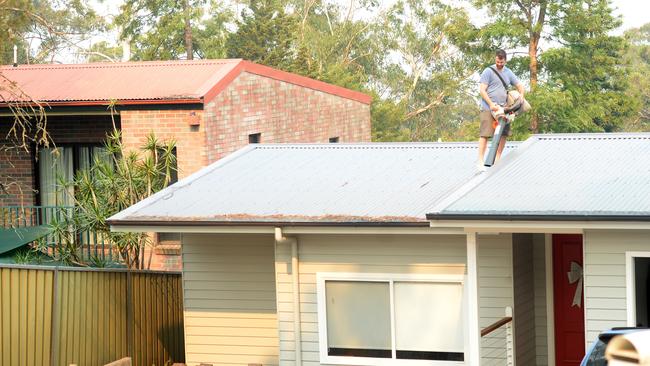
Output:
[{"xmin": 477, "ymin": 49, "xmax": 524, "ymax": 169}]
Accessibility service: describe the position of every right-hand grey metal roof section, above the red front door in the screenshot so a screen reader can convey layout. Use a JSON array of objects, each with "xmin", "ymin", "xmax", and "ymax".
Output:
[{"xmin": 427, "ymin": 133, "xmax": 650, "ymax": 221}]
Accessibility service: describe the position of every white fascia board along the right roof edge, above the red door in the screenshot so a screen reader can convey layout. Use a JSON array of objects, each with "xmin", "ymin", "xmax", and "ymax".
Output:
[{"xmin": 429, "ymin": 220, "xmax": 650, "ymax": 234}]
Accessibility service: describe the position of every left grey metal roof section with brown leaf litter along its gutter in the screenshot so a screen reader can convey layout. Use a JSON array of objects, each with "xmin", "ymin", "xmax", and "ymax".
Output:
[{"xmin": 109, "ymin": 143, "xmax": 513, "ymax": 225}]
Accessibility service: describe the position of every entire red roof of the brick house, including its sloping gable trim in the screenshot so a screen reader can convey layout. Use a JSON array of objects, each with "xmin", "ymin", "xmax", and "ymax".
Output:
[{"xmin": 0, "ymin": 59, "xmax": 371, "ymax": 106}]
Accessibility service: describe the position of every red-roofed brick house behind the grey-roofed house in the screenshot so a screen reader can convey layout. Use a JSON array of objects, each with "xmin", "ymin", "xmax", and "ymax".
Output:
[{"xmin": 0, "ymin": 59, "xmax": 371, "ymax": 267}]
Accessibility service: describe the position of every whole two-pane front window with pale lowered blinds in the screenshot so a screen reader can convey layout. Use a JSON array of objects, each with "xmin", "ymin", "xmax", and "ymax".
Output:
[{"xmin": 318, "ymin": 273, "xmax": 465, "ymax": 365}]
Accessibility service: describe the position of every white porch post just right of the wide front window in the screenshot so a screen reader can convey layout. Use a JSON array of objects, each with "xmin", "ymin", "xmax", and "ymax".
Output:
[{"xmin": 467, "ymin": 232, "xmax": 481, "ymax": 366}]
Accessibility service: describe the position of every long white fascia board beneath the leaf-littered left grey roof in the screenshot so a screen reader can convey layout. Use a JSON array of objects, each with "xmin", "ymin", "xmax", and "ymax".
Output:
[{"xmin": 111, "ymin": 225, "xmax": 465, "ymax": 235}]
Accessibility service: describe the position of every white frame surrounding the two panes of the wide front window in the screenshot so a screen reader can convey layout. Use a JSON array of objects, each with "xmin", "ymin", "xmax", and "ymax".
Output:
[{"xmin": 316, "ymin": 272, "xmax": 468, "ymax": 366}]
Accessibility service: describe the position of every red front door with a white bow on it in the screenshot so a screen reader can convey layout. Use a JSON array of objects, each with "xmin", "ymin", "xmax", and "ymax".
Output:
[{"xmin": 553, "ymin": 234, "xmax": 585, "ymax": 366}]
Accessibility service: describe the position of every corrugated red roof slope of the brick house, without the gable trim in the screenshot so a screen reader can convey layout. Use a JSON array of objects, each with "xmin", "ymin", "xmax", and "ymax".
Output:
[{"xmin": 0, "ymin": 60, "xmax": 241, "ymax": 102}]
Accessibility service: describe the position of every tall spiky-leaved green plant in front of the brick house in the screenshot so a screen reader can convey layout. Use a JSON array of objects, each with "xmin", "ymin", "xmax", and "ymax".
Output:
[{"xmin": 53, "ymin": 124, "xmax": 176, "ymax": 269}]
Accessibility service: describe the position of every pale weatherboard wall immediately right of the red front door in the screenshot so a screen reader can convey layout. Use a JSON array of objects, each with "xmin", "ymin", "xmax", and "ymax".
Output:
[{"xmin": 584, "ymin": 230, "xmax": 650, "ymax": 347}]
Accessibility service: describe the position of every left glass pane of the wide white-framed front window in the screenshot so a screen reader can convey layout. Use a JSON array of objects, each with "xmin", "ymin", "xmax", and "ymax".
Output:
[{"xmin": 325, "ymin": 281, "xmax": 392, "ymax": 358}]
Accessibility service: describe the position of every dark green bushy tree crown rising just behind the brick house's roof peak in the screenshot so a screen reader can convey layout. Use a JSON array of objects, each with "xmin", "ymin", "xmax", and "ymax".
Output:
[{"xmin": 226, "ymin": 0, "xmax": 296, "ymax": 69}]
